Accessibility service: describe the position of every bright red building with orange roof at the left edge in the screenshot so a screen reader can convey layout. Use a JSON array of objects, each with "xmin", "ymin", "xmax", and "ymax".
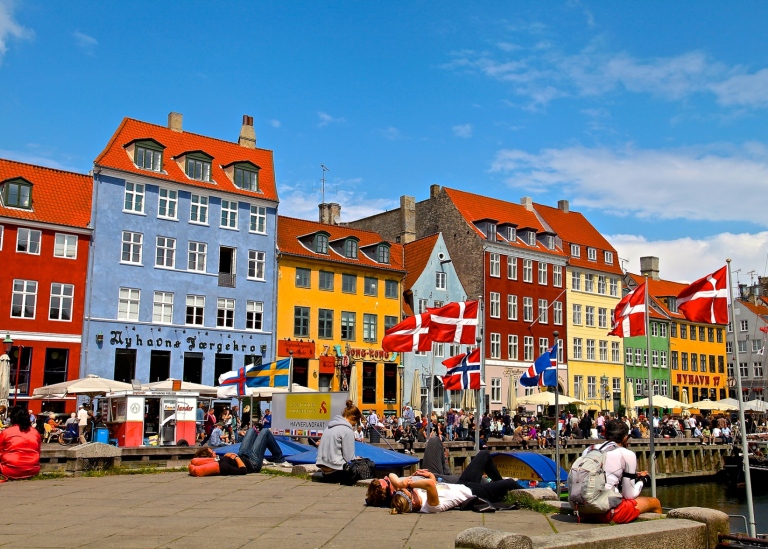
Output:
[{"xmin": 0, "ymin": 159, "xmax": 92, "ymax": 412}]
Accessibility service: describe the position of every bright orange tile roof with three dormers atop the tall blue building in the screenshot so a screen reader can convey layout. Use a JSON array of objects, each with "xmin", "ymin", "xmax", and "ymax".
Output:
[{"xmin": 94, "ymin": 118, "xmax": 278, "ymax": 202}]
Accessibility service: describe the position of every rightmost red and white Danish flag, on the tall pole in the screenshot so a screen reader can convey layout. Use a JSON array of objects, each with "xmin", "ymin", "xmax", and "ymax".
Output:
[{"xmin": 677, "ymin": 267, "xmax": 728, "ymax": 324}]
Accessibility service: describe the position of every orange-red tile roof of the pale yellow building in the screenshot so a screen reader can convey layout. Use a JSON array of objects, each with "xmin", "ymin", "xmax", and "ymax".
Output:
[{"xmin": 533, "ymin": 204, "xmax": 622, "ymax": 275}]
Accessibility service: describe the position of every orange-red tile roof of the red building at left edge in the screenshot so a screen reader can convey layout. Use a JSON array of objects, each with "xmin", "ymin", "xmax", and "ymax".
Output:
[{"xmin": 0, "ymin": 159, "xmax": 93, "ymax": 229}]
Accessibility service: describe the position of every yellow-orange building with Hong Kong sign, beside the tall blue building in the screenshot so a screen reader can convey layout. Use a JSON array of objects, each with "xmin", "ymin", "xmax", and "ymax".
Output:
[{"xmin": 276, "ymin": 210, "xmax": 405, "ymax": 417}]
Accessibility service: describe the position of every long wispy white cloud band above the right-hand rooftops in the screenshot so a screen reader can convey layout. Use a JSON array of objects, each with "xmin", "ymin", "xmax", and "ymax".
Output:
[{"xmin": 491, "ymin": 143, "xmax": 768, "ymax": 226}]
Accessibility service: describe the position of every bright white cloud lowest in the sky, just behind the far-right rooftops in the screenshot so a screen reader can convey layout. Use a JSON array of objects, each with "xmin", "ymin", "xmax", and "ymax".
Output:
[{"xmin": 606, "ymin": 232, "xmax": 768, "ymax": 283}]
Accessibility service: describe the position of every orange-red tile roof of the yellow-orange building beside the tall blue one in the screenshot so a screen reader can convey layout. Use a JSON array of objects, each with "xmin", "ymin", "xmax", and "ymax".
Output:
[{"xmin": 277, "ymin": 216, "xmax": 405, "ymax": 273}]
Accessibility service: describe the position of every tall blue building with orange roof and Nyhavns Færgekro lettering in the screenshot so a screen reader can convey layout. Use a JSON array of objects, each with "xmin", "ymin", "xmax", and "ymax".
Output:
[{"xmin": 81, "ymin": 113, "xmax": 278, "ymax": 385}]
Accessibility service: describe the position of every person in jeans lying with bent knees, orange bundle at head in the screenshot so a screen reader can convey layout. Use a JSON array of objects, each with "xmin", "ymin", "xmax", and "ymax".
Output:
[{"xmin": 189, "ymin": 429, "xmax": 290, "ymax": 477}]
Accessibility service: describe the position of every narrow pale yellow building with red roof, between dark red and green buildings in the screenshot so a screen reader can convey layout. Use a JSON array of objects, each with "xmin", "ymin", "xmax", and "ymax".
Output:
[{"xmin": 534, "ymin": 200, "xmax": 624, "ymax": 411}]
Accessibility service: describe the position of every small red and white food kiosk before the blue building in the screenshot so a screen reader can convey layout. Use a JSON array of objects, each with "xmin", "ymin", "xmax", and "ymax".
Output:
[{"xmin": 102, "ymin": 390, "xmax": 199, "ymax": 446}]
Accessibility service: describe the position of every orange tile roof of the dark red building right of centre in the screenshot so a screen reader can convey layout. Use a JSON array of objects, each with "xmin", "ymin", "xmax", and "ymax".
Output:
[{"xmin": 443, "ymin": 187, "xmax": 566, "ymax": 256}]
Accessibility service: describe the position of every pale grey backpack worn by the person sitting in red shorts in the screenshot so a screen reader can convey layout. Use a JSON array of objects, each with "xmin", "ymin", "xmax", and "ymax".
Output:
[{"xmin": 568, "ymin": 441, "xmax": 618, "ymax": 514}]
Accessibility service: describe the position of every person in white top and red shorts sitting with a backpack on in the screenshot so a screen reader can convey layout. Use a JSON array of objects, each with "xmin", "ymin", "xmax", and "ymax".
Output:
[{"xmin": 579, "ymin": 420, "xmax": 662, "ymax": 524}]
